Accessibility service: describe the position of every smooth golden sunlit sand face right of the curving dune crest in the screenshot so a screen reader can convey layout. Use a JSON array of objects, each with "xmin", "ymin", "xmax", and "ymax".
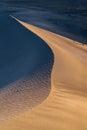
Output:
[{"xmin": 0, "ymin": 17, "xmax": 87, "ymax": 130}]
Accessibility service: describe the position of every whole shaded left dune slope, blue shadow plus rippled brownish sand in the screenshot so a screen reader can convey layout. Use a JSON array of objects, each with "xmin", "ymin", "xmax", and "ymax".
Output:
[{"xmin": 0, "ymin": 14, "xmax": 53, "ymax": 121}]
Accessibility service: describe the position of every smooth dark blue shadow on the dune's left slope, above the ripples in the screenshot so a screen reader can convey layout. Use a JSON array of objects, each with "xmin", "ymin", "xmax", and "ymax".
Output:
[{"xmin": 0, "ymin": 12, "xmax": 53, "ymax": 88}]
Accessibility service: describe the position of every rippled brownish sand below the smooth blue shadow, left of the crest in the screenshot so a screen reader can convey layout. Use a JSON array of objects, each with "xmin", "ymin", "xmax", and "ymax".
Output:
[{"xmin": 0, "ymin": 61, "xmax": 52, "ymax": 121}]
